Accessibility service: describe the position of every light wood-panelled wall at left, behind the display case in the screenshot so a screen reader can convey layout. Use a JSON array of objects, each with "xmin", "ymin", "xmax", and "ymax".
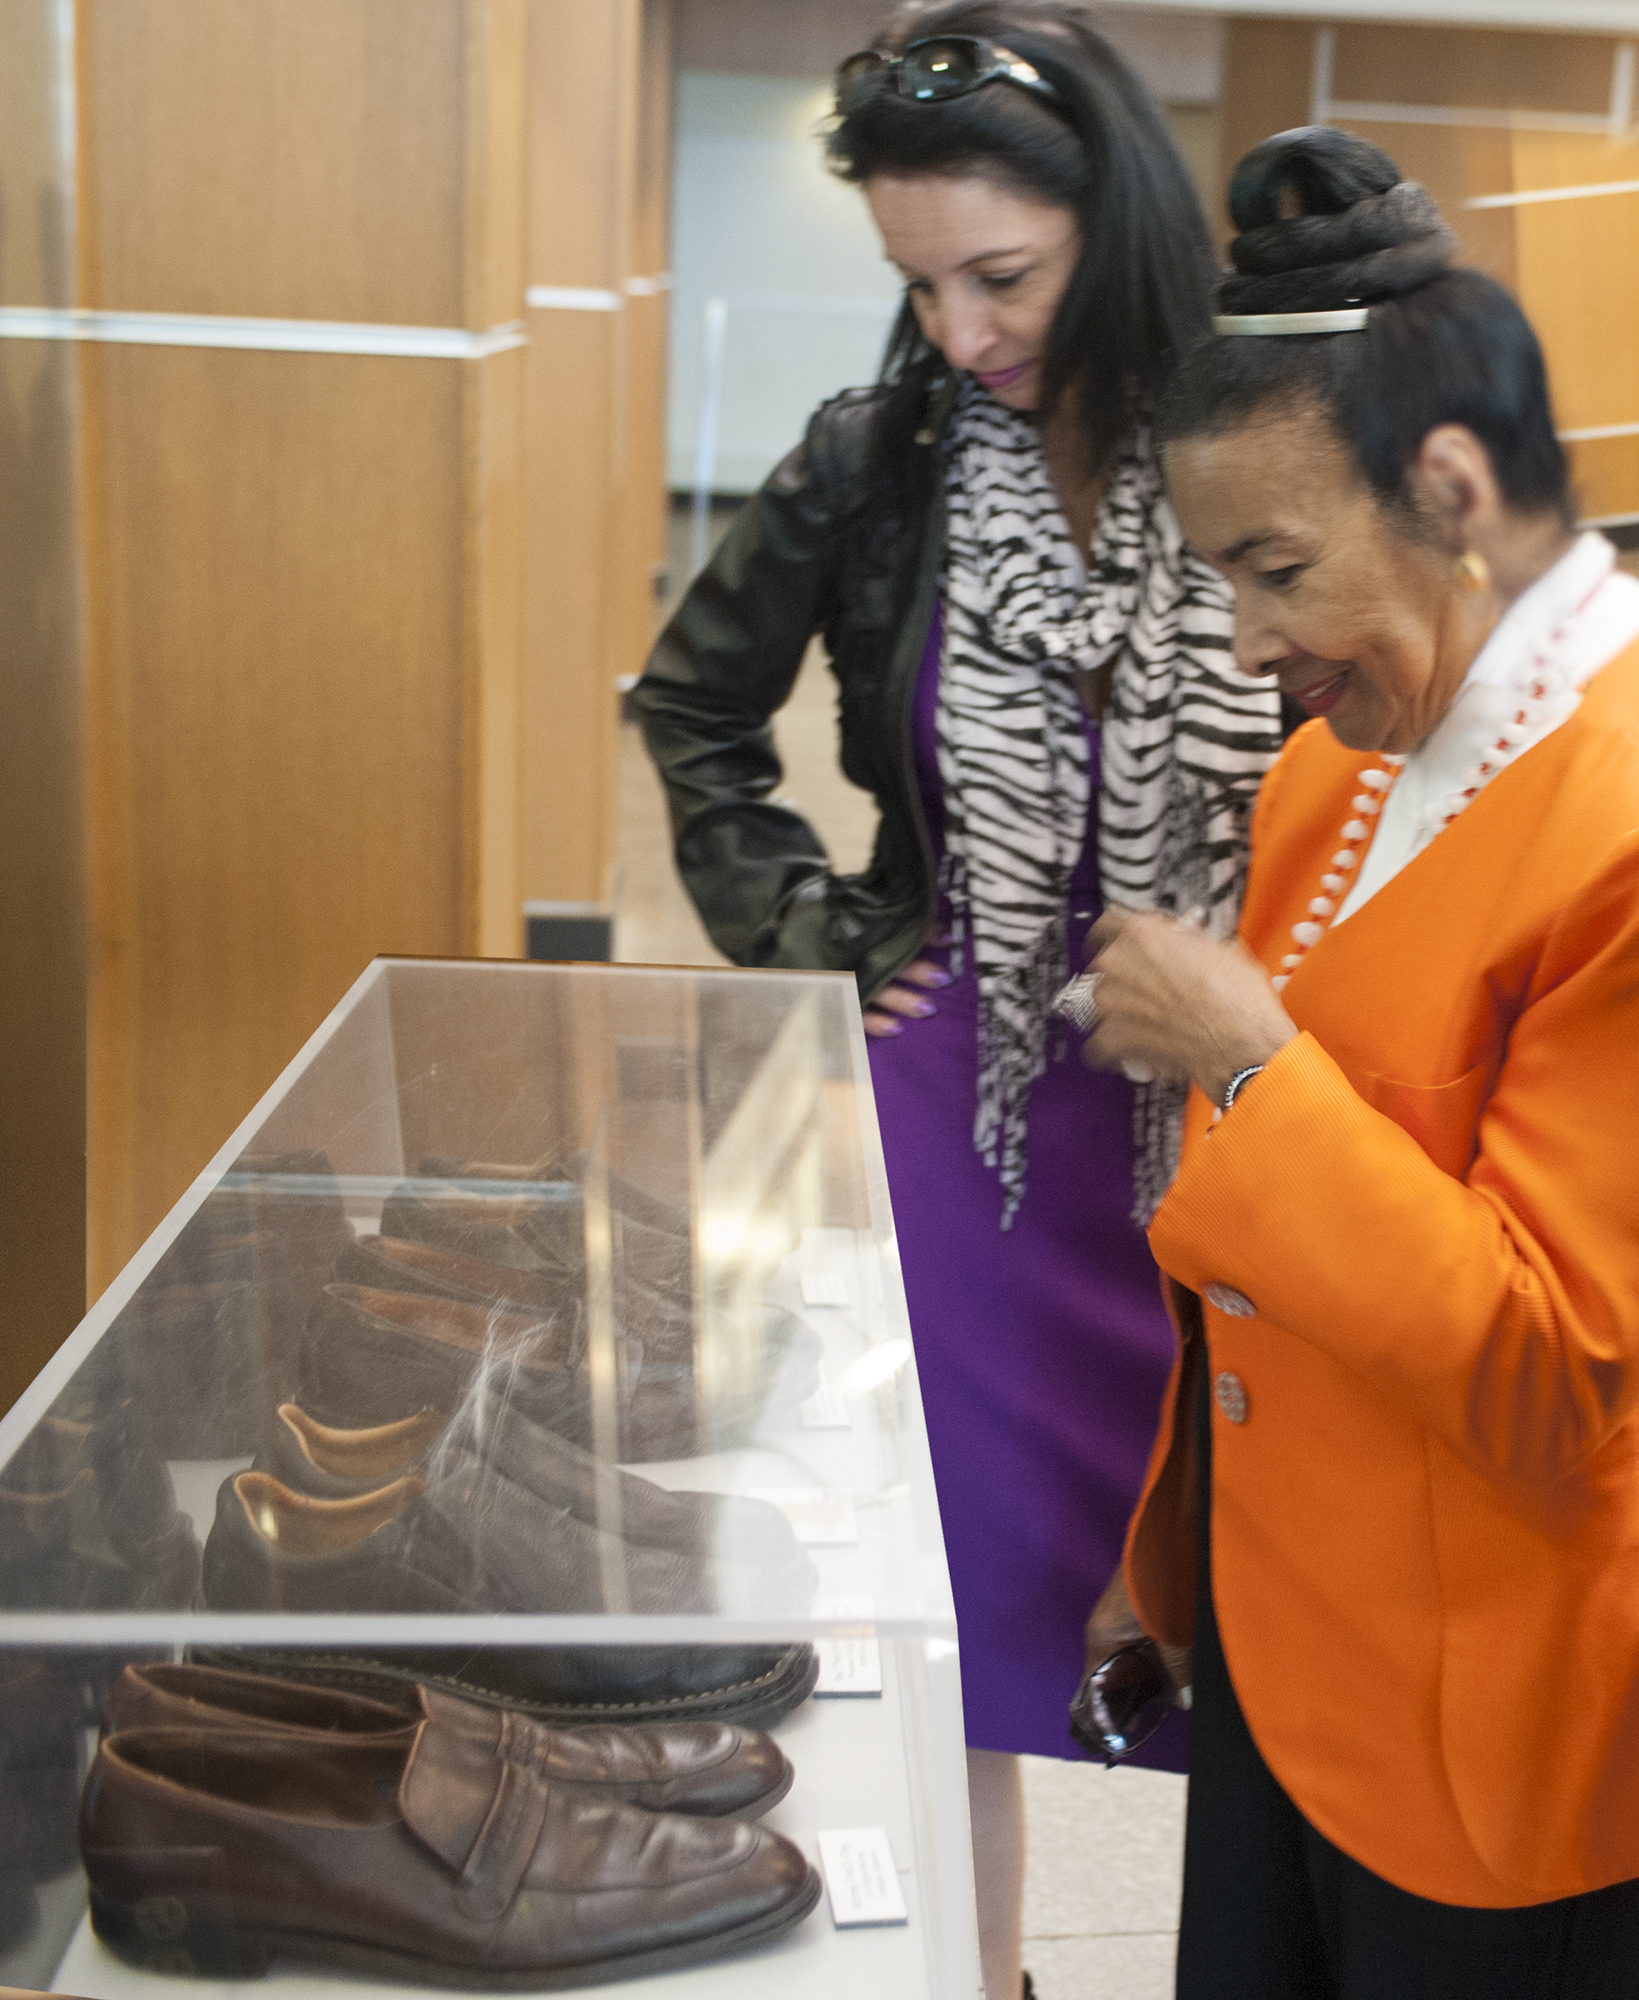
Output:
[{"xmin": 0, "ymin": 0, "xmax": 670, "ymax": 1352}]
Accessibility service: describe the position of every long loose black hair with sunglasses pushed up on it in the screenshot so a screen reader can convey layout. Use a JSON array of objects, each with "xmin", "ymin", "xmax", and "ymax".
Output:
[{"xmin": 827, "ymin": 0, "xmax": 1215, "ymax": 482}]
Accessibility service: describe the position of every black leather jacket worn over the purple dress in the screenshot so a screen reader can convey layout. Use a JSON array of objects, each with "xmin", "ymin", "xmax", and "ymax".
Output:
[{"xmin": 632, "ymin": 378, "xmax": 955, "ymax": 998}]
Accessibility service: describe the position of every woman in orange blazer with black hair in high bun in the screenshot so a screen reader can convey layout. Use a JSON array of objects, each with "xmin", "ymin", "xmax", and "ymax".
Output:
[{"xmin": 1083, "ymin": 130, "xmax": 1639, "ymax": 2000}]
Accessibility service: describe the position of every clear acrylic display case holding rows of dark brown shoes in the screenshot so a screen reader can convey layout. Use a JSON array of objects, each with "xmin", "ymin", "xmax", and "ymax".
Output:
[{"xmin": 0, "ymin": 960, "xmax": 979, "ymax": 2000}]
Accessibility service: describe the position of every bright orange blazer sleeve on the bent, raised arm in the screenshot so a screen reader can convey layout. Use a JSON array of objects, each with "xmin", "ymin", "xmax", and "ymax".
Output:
[{"xmin": 1149, "ymin": 834, "xmax": 1639, "ymax": 1484}]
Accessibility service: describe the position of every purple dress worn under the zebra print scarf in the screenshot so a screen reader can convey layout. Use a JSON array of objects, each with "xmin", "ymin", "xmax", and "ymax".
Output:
[{"xmin": 869, "ymin": 618, "xmax": 1185, "ymax": 1770}]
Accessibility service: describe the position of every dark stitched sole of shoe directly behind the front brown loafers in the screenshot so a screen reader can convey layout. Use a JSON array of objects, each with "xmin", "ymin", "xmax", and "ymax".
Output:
[{"xmin": 184, "ymin": 1646, "xmax": 820, "ymax": 1730}]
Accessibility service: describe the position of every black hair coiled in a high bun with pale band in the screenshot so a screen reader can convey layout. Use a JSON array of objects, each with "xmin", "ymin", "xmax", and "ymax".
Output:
[{"xmin": 1161, "ymin": 126, "xmax": 1575, "ymax": 538}]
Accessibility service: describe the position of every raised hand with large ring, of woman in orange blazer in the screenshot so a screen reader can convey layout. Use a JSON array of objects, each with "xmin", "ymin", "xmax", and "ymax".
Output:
[{"xmin": 1081, "ymin": 910, "xmax": 1297, "ymax": 1104}]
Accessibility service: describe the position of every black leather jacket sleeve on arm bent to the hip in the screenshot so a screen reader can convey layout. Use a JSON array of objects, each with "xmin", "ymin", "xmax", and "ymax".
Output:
[{"xmin": 632, "ymin": 398, "xmax": 867, "ymax": 966}]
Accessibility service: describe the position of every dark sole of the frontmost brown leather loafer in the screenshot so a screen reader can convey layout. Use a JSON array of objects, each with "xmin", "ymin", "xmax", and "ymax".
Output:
[{"xmin": 90, "ymin": 1868, "xmax": 821, "ymax": 1992}]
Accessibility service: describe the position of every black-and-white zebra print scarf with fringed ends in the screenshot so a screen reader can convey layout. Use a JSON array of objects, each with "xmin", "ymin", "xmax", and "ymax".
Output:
[{"xmin": 939, "ymin": 382, "xmax": 1279, "ymax": 1228}]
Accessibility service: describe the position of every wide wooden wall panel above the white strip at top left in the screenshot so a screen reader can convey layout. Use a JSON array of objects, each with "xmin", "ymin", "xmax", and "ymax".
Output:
[{"xmin": 78, "ymin": 0, "xmax": 469, "ymax": 326}]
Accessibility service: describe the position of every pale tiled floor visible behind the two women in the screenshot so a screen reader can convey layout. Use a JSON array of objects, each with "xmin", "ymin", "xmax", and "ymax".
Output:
[{"xmin": 616, "ymin": 524, "xmax": 1183, "ymax": 2000}]
